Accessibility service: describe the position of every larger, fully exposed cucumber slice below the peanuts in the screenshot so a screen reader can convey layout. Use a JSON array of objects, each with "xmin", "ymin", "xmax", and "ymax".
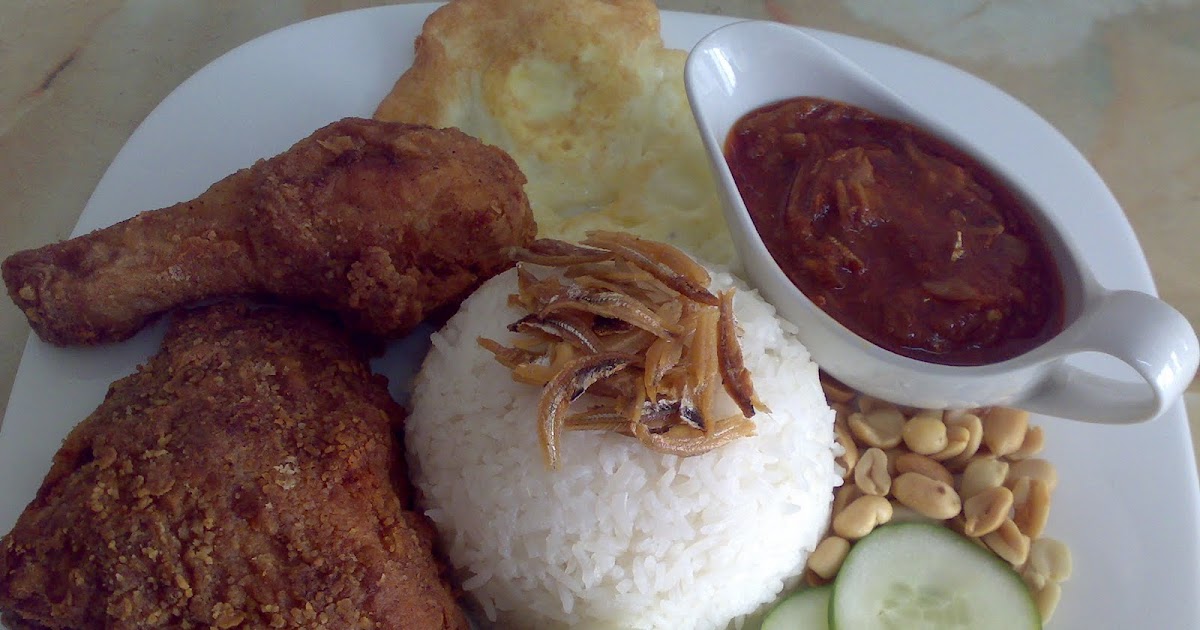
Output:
[{"xmin": 829, "ymin": 523, "xmax": 1042, "ymax": 630}]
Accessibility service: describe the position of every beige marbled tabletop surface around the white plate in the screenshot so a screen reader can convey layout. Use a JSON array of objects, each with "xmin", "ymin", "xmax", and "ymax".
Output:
[{"xmin": 0, "ymin": 0, "xmax": 1200, "ymax": 470}]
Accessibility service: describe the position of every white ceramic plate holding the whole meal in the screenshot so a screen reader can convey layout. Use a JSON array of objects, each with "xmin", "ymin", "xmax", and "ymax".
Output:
[{"xmin": 0, "ymin": 5, "xmax": 1200, "ymax": 629}]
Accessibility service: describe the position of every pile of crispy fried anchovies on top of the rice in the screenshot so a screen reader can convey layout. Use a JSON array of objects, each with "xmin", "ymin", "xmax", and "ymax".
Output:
[{"xmin": 479, "ymin": 232, "xmax": 764, "ymax": 468}]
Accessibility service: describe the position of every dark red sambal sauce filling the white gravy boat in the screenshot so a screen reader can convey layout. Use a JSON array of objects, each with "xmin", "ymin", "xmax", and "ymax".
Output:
[{"xmin": 725, "ymin": 97, "xmax": 1063, "ymax": 365}]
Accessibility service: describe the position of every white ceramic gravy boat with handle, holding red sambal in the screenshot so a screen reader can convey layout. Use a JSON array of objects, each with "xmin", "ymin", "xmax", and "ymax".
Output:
[{"xmin": 685, "ymin": 22, "xmax": 1200, "ymax": 424}]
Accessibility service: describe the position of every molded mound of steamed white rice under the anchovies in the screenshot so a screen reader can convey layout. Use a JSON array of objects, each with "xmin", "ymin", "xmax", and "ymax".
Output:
[{"xmin": 406, "ymin": 266, "xmax": 840, "ymax": 630}]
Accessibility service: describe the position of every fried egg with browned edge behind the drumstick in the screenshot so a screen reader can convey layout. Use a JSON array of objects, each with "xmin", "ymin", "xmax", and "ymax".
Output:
[{"xmin": 376, "ymin": 0, "xmax": 733, "ymax": 263}]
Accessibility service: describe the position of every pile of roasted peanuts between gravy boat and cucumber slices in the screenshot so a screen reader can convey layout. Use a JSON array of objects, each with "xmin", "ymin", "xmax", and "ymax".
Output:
[{"xmin": 804, "ymin": 384, "xmax": 1072, "ymax": 604}]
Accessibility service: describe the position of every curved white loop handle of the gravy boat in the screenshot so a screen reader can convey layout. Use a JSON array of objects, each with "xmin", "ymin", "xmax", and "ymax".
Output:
[{"xmin": 1016, "ymin": 290, "xmax": 1200, "ymax": 425}]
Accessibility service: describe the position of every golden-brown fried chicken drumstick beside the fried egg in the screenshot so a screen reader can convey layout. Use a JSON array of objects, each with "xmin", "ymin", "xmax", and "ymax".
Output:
[{"xmin": 2, "ymin": 119, "xmax": 536, "ymax": 346}]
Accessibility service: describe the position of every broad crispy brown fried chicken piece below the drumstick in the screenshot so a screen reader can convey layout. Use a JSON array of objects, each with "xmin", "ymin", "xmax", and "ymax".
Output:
[{"xmin": 0, "ymin": 304, "xmax": 467, "ymax": 630}]
